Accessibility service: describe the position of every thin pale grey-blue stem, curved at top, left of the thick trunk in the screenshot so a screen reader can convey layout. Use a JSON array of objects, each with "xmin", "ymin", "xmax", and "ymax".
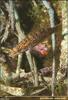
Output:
[{"xmin": 43, "ymin": 0, "xmax": 56, "ymax": 96}]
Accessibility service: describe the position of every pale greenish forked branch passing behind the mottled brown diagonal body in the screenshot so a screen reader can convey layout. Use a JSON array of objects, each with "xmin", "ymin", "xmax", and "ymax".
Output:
[{"xmin": 15, "ymin": 8, "xmax": 38, "ymax": 86}]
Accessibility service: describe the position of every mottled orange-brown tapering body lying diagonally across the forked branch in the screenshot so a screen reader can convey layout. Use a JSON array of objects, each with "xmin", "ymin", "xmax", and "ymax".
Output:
[{"xmin": 9, "ymin": 24, "xmax": 60, "ymax": 57}]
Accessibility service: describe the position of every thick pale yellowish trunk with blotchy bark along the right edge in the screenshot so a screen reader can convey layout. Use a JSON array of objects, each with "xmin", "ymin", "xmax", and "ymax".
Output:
[{"xmin": 57, "ymin": 0, "xmax": 68, "ymax": 85}]
